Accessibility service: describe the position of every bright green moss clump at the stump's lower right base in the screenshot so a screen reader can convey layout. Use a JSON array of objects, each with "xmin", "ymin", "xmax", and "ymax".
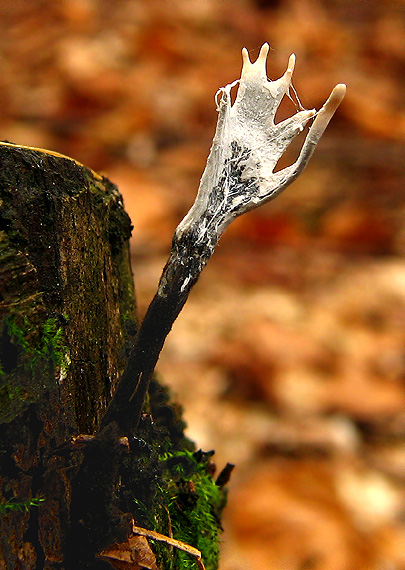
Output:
[{"xmin": 154, "ymin": 451, "xmax": 225, "ymax": 570}]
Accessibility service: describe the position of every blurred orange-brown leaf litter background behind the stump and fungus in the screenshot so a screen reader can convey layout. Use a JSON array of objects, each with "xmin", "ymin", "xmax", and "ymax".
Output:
[{"xmin": 0, "ymin": 0, "xmax": 405, "ymax": 570}]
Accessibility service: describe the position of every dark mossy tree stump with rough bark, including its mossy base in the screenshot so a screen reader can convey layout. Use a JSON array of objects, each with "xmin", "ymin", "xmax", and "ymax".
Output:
[{"xmin": 0, "ymin": 143, "xmax": 229, "ymax": 570}]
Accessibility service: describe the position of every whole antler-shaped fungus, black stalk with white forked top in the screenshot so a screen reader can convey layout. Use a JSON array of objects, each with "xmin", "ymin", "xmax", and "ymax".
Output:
[{"xmin": 101, "ymin": 44, "xmax": 346, "ymax": 435}]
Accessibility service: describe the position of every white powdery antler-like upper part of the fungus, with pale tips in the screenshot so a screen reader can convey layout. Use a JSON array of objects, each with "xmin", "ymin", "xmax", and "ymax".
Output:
[{"xmin": 176, "ymin": 43, "xmax": 346, "ymax": 241}]
